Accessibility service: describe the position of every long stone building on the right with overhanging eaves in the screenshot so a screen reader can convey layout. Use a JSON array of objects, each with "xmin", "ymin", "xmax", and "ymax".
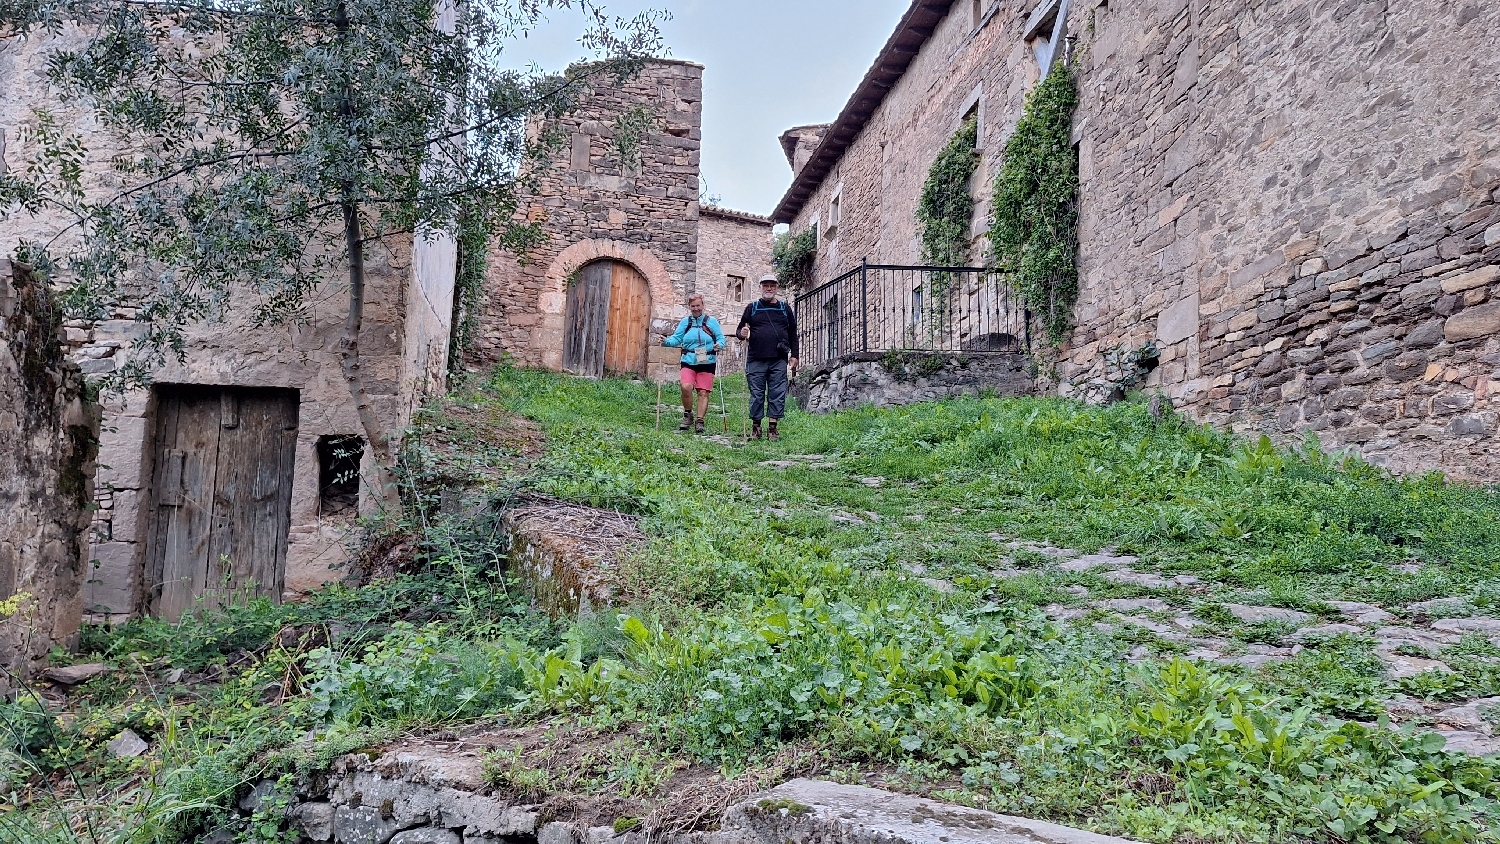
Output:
[{"xmin": 773, "ymin": 0, "xmax": 1500, "ymax": 481}]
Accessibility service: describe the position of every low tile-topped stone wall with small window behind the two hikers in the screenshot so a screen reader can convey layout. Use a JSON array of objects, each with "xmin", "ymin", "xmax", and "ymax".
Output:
[{"xmin": 698, "ymin": 205, "xmax": 771, "ymax": 373}]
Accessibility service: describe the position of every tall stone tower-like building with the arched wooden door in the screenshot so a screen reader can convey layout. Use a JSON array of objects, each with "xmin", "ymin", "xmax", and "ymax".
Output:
[{"xmin": 474, "ymin": 60, "xmax": 771, "ymax": 381}]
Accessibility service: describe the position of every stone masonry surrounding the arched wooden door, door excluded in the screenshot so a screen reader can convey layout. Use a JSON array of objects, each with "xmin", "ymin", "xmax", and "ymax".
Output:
[{"xmin": 473, "ymin": 60, "xmax": 771, "ymax": 379}]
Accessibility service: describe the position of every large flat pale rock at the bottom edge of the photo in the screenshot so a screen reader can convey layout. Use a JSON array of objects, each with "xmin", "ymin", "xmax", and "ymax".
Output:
[{"xmin": 723, "ymin": 780, "xmax": 1125, "ymax": 844}]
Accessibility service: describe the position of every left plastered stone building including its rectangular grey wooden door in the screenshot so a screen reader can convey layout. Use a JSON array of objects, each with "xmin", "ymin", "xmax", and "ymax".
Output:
[{"xmin": 0, "ymin": 27, "xmax": 456, "ymax": 619}]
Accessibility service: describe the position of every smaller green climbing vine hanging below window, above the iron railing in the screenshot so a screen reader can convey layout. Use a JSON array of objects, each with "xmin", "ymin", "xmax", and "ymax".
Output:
[{"xmin": 917, "ymin": 117, "xmax": 980, "ymax": 267}]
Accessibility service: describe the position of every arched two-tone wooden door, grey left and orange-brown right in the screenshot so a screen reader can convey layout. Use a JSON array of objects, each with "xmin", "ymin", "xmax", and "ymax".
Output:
[{"xmin": 563, "ymin": 259, "xmax": 651, "ymax": 378}]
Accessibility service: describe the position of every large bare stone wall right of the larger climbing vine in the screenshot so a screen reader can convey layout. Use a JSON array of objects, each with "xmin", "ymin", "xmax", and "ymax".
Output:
[{"xmin": 1061, "ymin": 0, "xmax": 1500, "ymax": 481}]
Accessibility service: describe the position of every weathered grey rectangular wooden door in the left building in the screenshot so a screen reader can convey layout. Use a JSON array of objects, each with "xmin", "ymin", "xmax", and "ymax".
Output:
[{"xmin": 146, "ymin": 385, "xmax": 297, "ymax": 621}]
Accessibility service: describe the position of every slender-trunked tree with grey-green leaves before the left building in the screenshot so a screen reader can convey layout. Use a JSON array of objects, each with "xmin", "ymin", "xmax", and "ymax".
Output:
[{"xmin": 0, "ymin": 0, "xmax": 662, "ymax": 507}]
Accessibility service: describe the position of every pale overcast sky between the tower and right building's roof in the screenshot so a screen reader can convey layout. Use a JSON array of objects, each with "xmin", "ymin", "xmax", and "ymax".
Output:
[{"xmin": 510, "ymin": 0, "xmax": 911, "ymax": 214}]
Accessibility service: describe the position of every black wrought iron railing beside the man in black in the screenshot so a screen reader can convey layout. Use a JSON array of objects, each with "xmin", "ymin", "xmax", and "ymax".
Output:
[{"xmin": 794, "ymin": 264, "xmax": 1031, "ymax": 369}]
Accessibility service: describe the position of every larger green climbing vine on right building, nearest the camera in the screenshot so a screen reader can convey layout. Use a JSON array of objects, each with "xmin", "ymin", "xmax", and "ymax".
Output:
[{"xmin": 990, "ymin": 64, "xmax": 1079, "ymax": 345}]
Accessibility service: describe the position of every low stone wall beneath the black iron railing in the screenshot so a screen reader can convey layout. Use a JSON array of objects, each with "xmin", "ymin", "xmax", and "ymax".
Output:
[{"xmin": 792, "ymin": 352, "xmax": 1037, "ymax": 414}]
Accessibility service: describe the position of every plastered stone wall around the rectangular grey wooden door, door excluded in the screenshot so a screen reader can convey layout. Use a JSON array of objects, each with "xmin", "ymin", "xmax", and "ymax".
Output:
[{"xmin": 0, "ymin": 25, "xmax": 456, "ymax": 619}]
